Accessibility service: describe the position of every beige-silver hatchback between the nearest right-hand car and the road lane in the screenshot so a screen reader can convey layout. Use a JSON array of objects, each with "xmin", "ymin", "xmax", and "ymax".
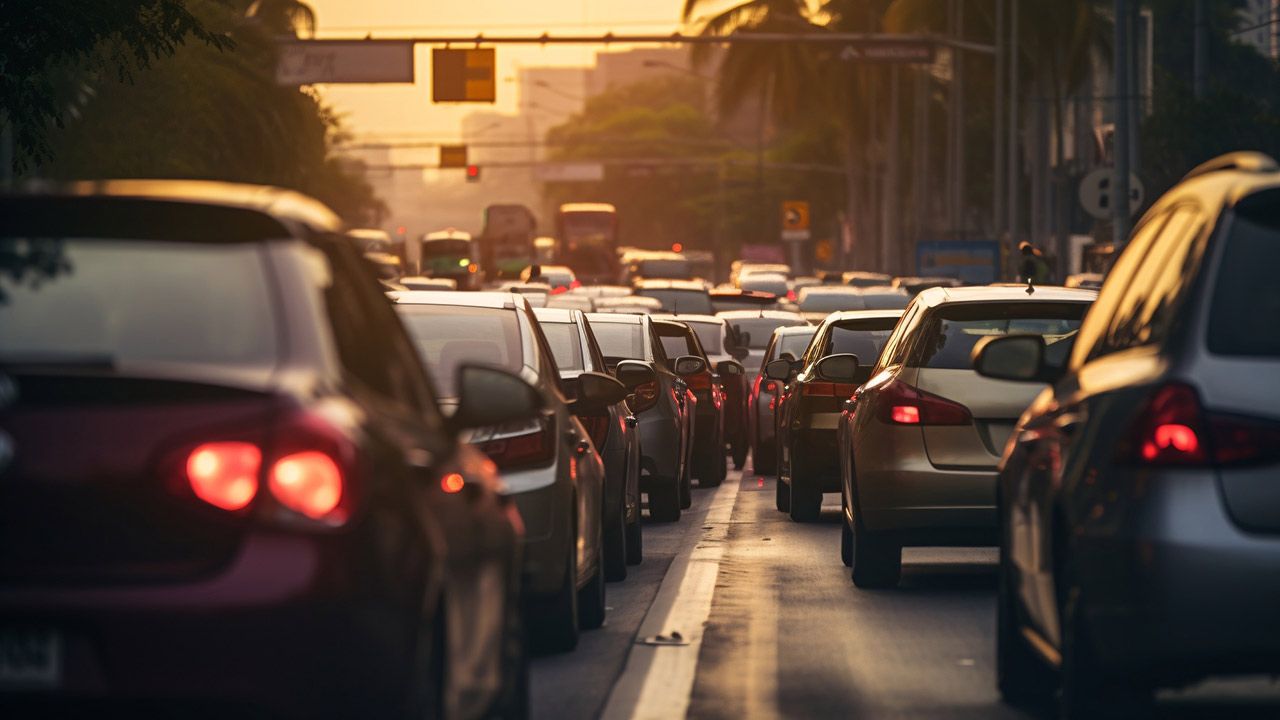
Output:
[{"xmin": 837, "ymin": 287, "xmax": 1096, "ymax": 588}]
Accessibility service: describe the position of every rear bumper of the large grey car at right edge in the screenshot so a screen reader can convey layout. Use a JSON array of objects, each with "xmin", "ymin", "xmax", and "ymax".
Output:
[{"xmin": 1073, "ymin": 470, "xmax": 1280, "ymax": 682}]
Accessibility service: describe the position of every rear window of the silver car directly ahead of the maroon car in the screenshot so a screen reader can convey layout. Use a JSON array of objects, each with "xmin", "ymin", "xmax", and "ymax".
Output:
[{"xmin": 396, "ymin": 305, "xmax": 525, "ymax": 397}]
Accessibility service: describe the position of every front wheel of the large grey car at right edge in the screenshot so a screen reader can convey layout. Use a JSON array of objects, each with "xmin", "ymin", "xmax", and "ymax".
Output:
[{"xmin": 996, "ymin": 537, "xmax": 1057, "ymax": 707}]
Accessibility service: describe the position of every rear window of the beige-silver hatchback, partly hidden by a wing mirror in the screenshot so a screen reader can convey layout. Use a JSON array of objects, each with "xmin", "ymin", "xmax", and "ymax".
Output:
[{"xmin": 910, "ymin": 302, "xmax": 1089, "ymax": 370}]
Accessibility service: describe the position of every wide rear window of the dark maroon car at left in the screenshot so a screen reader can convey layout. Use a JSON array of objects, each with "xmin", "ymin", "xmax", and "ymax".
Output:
[{"xmin": 0, "ymin": 237, "xmax": 279, "ymax": 366}]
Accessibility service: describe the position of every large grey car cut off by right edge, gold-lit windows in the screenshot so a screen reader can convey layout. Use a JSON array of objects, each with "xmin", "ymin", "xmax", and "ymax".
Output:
[{"xmin": 975, "ymin": 154, "xmax": 1280, "ymax": 719}]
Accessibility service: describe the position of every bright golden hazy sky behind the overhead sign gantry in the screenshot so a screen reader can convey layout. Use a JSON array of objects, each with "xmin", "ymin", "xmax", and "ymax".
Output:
[{"xmin": 308, "ymin": 0, "xmax": 711, "ymax": 138}]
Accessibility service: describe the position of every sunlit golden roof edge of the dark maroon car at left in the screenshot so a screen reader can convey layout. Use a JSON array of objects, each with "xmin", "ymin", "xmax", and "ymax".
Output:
[{"xmin": 0, "ymin": 179, "xmax": 343, "ymax": 232}]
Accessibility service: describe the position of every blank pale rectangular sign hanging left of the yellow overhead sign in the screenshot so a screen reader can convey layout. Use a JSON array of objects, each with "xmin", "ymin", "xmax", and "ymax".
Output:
[{"xmin": 275, "ymin": 40, "xmax": 413, "ymax": 86}]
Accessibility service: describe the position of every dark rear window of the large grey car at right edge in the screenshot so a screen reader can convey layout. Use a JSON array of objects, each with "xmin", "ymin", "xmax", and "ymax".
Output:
[{"xmin": 1208, "ymin": 209, "xmax": 1280, "ymax": 357}]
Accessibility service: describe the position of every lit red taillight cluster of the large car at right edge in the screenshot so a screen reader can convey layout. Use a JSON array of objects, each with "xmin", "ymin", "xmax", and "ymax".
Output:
[{"xmin": 1119, "ymin": 383, "xmax": 1280, "ymax": 468}]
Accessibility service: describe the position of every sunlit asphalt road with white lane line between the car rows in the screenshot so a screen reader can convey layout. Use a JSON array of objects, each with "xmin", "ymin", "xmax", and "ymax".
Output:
[{"xmin": 532, "ymin": 458, "xmax": 1280, "ymax": 720}]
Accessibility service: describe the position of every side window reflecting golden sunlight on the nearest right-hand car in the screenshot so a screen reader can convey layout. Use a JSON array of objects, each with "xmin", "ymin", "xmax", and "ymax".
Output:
[{"xmin": 1106, "ymin": 205, "xmax": 1204, "ymax": 351}]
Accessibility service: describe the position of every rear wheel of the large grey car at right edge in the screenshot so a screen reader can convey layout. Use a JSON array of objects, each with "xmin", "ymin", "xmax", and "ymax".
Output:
[{"xmin": 1059, "ymin": 583, "xmax": 1152, "ymax": 720}]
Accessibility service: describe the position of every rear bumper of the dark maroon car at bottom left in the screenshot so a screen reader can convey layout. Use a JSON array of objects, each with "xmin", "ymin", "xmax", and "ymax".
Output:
[{"xmin": 0, "ymin": 533, "xmax": 439, "ymax": 716}]
